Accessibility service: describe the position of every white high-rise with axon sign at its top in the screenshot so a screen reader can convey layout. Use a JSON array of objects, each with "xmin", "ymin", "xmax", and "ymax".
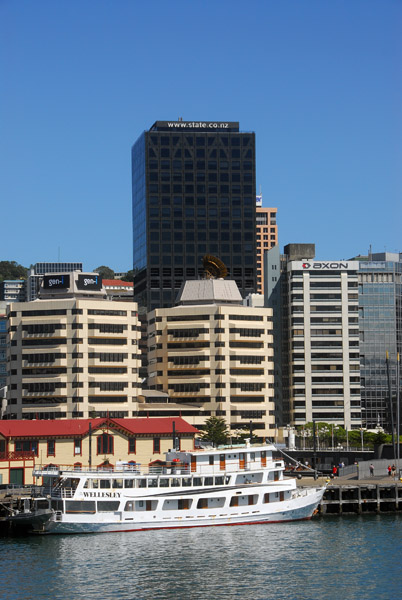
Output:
[{"xmin": 266, "ymin": 244, "xmax": 362, "ymax": 429}]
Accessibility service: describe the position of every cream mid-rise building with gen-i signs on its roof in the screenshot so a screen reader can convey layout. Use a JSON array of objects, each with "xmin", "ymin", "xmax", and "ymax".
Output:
[{"xmin": 3, "ymin": 271, "xmax": 141, "ymax": 419}]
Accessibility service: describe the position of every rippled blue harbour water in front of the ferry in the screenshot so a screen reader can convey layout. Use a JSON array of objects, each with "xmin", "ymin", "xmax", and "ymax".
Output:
[{"xmin": 0, "ymin": 515, "xmax": 402, "ymax": 600}]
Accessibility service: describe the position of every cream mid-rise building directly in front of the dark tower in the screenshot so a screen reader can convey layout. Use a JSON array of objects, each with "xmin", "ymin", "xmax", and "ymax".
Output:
[{"xmin": 148, "ymin": 279, "xmax": 275, "ymax": 437}]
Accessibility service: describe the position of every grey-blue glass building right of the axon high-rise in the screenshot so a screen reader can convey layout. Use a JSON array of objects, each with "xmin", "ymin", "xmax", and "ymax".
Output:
[{"xmin": 359, "ymin": 253, "xmax": 402, "ymax": 431}]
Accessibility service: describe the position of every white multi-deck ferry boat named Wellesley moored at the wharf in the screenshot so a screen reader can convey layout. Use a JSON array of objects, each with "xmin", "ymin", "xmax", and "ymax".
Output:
[{"xmin": 25, "ymin": 444, "xmax": 325, "ymax": 534}]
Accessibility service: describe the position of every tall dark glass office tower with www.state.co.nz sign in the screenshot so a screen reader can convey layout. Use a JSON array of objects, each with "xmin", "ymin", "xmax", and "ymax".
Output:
[{"xmin": 132, "ymin": 121, "xmax": 256, "ymax": 310}]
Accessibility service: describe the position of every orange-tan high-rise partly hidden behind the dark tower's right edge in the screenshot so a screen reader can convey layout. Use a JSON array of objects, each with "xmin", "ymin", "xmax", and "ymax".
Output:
[{"xmin": 256, "ymin": 202, "xmax": 278, "ymax": 294}]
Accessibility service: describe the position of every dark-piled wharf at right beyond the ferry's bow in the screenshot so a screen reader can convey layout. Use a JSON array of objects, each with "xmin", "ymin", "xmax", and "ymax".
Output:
[{"xmin": 297, "ymin": 476, "xmax": 402, "ymax": 516}]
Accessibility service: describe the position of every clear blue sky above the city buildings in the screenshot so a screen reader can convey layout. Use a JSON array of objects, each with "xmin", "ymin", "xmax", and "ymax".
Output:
[{"xmin": 0, "ymin": 0, "xmax": 402, "ymax": 271}]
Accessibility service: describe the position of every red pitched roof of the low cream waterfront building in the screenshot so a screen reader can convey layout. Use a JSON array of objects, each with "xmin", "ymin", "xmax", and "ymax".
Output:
[{"xmin": 0, "ymin": 417, "xmax": 198, "ymax": 438}]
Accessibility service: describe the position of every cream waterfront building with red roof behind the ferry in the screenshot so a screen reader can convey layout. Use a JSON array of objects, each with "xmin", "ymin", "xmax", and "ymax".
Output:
[{"xmin": 0, "ymin": 417, "xmax": 198, "ymax": 484}]
